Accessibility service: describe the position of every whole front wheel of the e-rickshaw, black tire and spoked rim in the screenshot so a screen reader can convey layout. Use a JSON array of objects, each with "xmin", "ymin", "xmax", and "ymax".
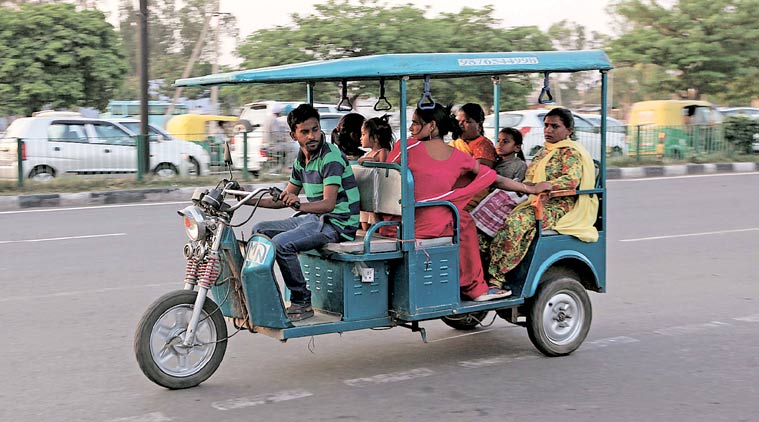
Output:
[{"xmin": 134, "ymin": 290, "xmax": 227, "ymax": 390}]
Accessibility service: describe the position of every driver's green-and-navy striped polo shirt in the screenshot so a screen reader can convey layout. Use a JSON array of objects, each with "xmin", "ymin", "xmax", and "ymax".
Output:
[{"xmin": 290, "ymin": 141, "xmax": 359, "ymax": 240}]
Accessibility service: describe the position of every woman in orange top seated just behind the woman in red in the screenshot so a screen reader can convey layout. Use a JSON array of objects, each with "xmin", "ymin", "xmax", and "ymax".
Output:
[{"xmin": 450, "ymin": 103, "xmax": 497, "ymax": 211}]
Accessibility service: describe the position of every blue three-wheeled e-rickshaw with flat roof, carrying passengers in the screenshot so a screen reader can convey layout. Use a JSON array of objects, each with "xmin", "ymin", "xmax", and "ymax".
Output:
[{"xmin": 135, "ymin": 51, "xmax": 612, "ymax": 389}]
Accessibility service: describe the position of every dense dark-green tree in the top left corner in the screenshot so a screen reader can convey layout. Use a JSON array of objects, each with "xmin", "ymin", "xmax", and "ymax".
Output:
[{"xmin": 0, "ymin": 4, "xmax": 127, "ymax": 115}]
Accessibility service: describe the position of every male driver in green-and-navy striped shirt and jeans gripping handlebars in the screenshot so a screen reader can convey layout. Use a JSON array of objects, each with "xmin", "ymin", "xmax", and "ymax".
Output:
[{"xmin": 243, "ymin": 104, "xmax": 359, "ymax": 321}]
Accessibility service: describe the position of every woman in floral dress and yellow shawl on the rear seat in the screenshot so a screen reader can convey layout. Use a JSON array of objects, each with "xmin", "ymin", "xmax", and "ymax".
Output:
[{"xmin": 488, "ymin": 108, "xmax": 598, "ymax": 288}]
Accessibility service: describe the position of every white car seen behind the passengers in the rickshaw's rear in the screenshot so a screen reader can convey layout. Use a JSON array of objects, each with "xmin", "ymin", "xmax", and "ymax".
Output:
[{"xmin": 483, "ymin": 109, "xmax": 627, "ymax": 160}]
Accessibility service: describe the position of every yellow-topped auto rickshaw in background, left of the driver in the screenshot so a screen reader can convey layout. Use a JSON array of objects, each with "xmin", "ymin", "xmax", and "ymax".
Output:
[{"xmin": 166, "ymin": 114, "xmax": 239, "ymax": 166}]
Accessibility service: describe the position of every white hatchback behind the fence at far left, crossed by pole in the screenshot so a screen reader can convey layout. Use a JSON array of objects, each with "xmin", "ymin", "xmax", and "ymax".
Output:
[{"xmin": 0, "ymin": 112, "xmax": 208, "ymax": 181}]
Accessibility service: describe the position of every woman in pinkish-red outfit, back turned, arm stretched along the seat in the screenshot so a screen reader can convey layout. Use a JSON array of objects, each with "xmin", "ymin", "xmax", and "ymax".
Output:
[{"xmin": 386, "ymin": 104, "xmax": 550, "ymax": 302}]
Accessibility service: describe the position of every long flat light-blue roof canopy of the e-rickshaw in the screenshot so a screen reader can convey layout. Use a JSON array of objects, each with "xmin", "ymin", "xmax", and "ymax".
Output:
[{"xmin": 175, "ymin": 50, "xmax": 612, "ymax": 86}]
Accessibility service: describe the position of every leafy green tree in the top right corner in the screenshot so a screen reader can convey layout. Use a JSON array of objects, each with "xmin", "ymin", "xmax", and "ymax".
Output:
[{"xmin": 609, "ymin": 0, "xmax": 759, "ymax": 103}]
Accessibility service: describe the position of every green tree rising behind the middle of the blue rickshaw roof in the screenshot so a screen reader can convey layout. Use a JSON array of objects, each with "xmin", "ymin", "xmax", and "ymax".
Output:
[{"xmin": 229, "ymin": 0, "xmax": 552, "ymax": 113}]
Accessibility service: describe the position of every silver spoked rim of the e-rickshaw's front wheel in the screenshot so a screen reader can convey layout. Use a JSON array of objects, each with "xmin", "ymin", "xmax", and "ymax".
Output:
[{"xmin": 150, "ymin": 304, "xmax": 216, "ymax": 377}]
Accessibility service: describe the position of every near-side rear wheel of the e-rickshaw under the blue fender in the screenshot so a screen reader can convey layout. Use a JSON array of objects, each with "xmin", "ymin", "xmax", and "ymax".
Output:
[{"xmin": 527, "ymin": 271, "xmax": 593, "ymax": 356}]
